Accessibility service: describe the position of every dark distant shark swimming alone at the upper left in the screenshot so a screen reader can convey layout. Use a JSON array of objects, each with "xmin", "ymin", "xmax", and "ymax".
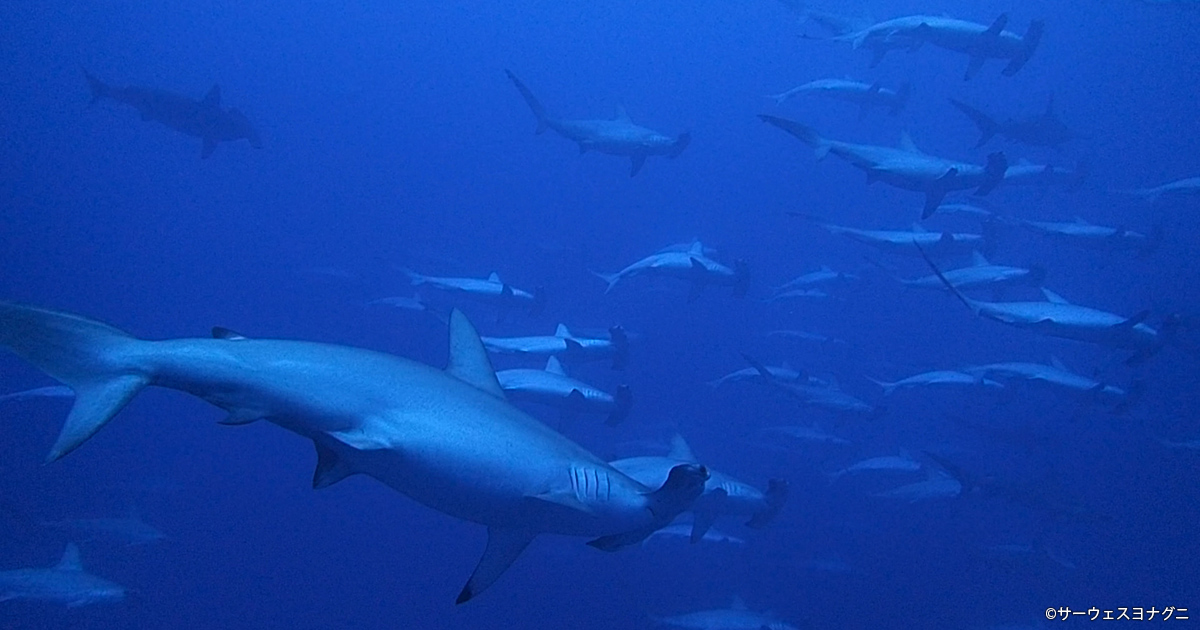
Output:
[{"xmin": 84, "ymin": 71, "xmax": 263, "ymax": 157}]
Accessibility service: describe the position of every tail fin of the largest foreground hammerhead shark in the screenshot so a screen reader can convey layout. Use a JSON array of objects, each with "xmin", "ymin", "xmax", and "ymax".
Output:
[{"xmin": 0, "ymin": 302, "xmax": 150, "ymax": 462}]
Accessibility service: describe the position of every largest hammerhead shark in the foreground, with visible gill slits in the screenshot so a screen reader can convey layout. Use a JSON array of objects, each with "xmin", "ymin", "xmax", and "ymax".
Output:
[{"xmin": 0, "ymin": 302, "xmax": 708, "ymax": 604}]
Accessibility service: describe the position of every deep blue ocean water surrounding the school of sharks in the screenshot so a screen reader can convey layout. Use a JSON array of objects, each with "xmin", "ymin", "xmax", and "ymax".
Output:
[{"xmin": 0, "ymin": 0, "xmax": 1200, "ymax": 629}]
